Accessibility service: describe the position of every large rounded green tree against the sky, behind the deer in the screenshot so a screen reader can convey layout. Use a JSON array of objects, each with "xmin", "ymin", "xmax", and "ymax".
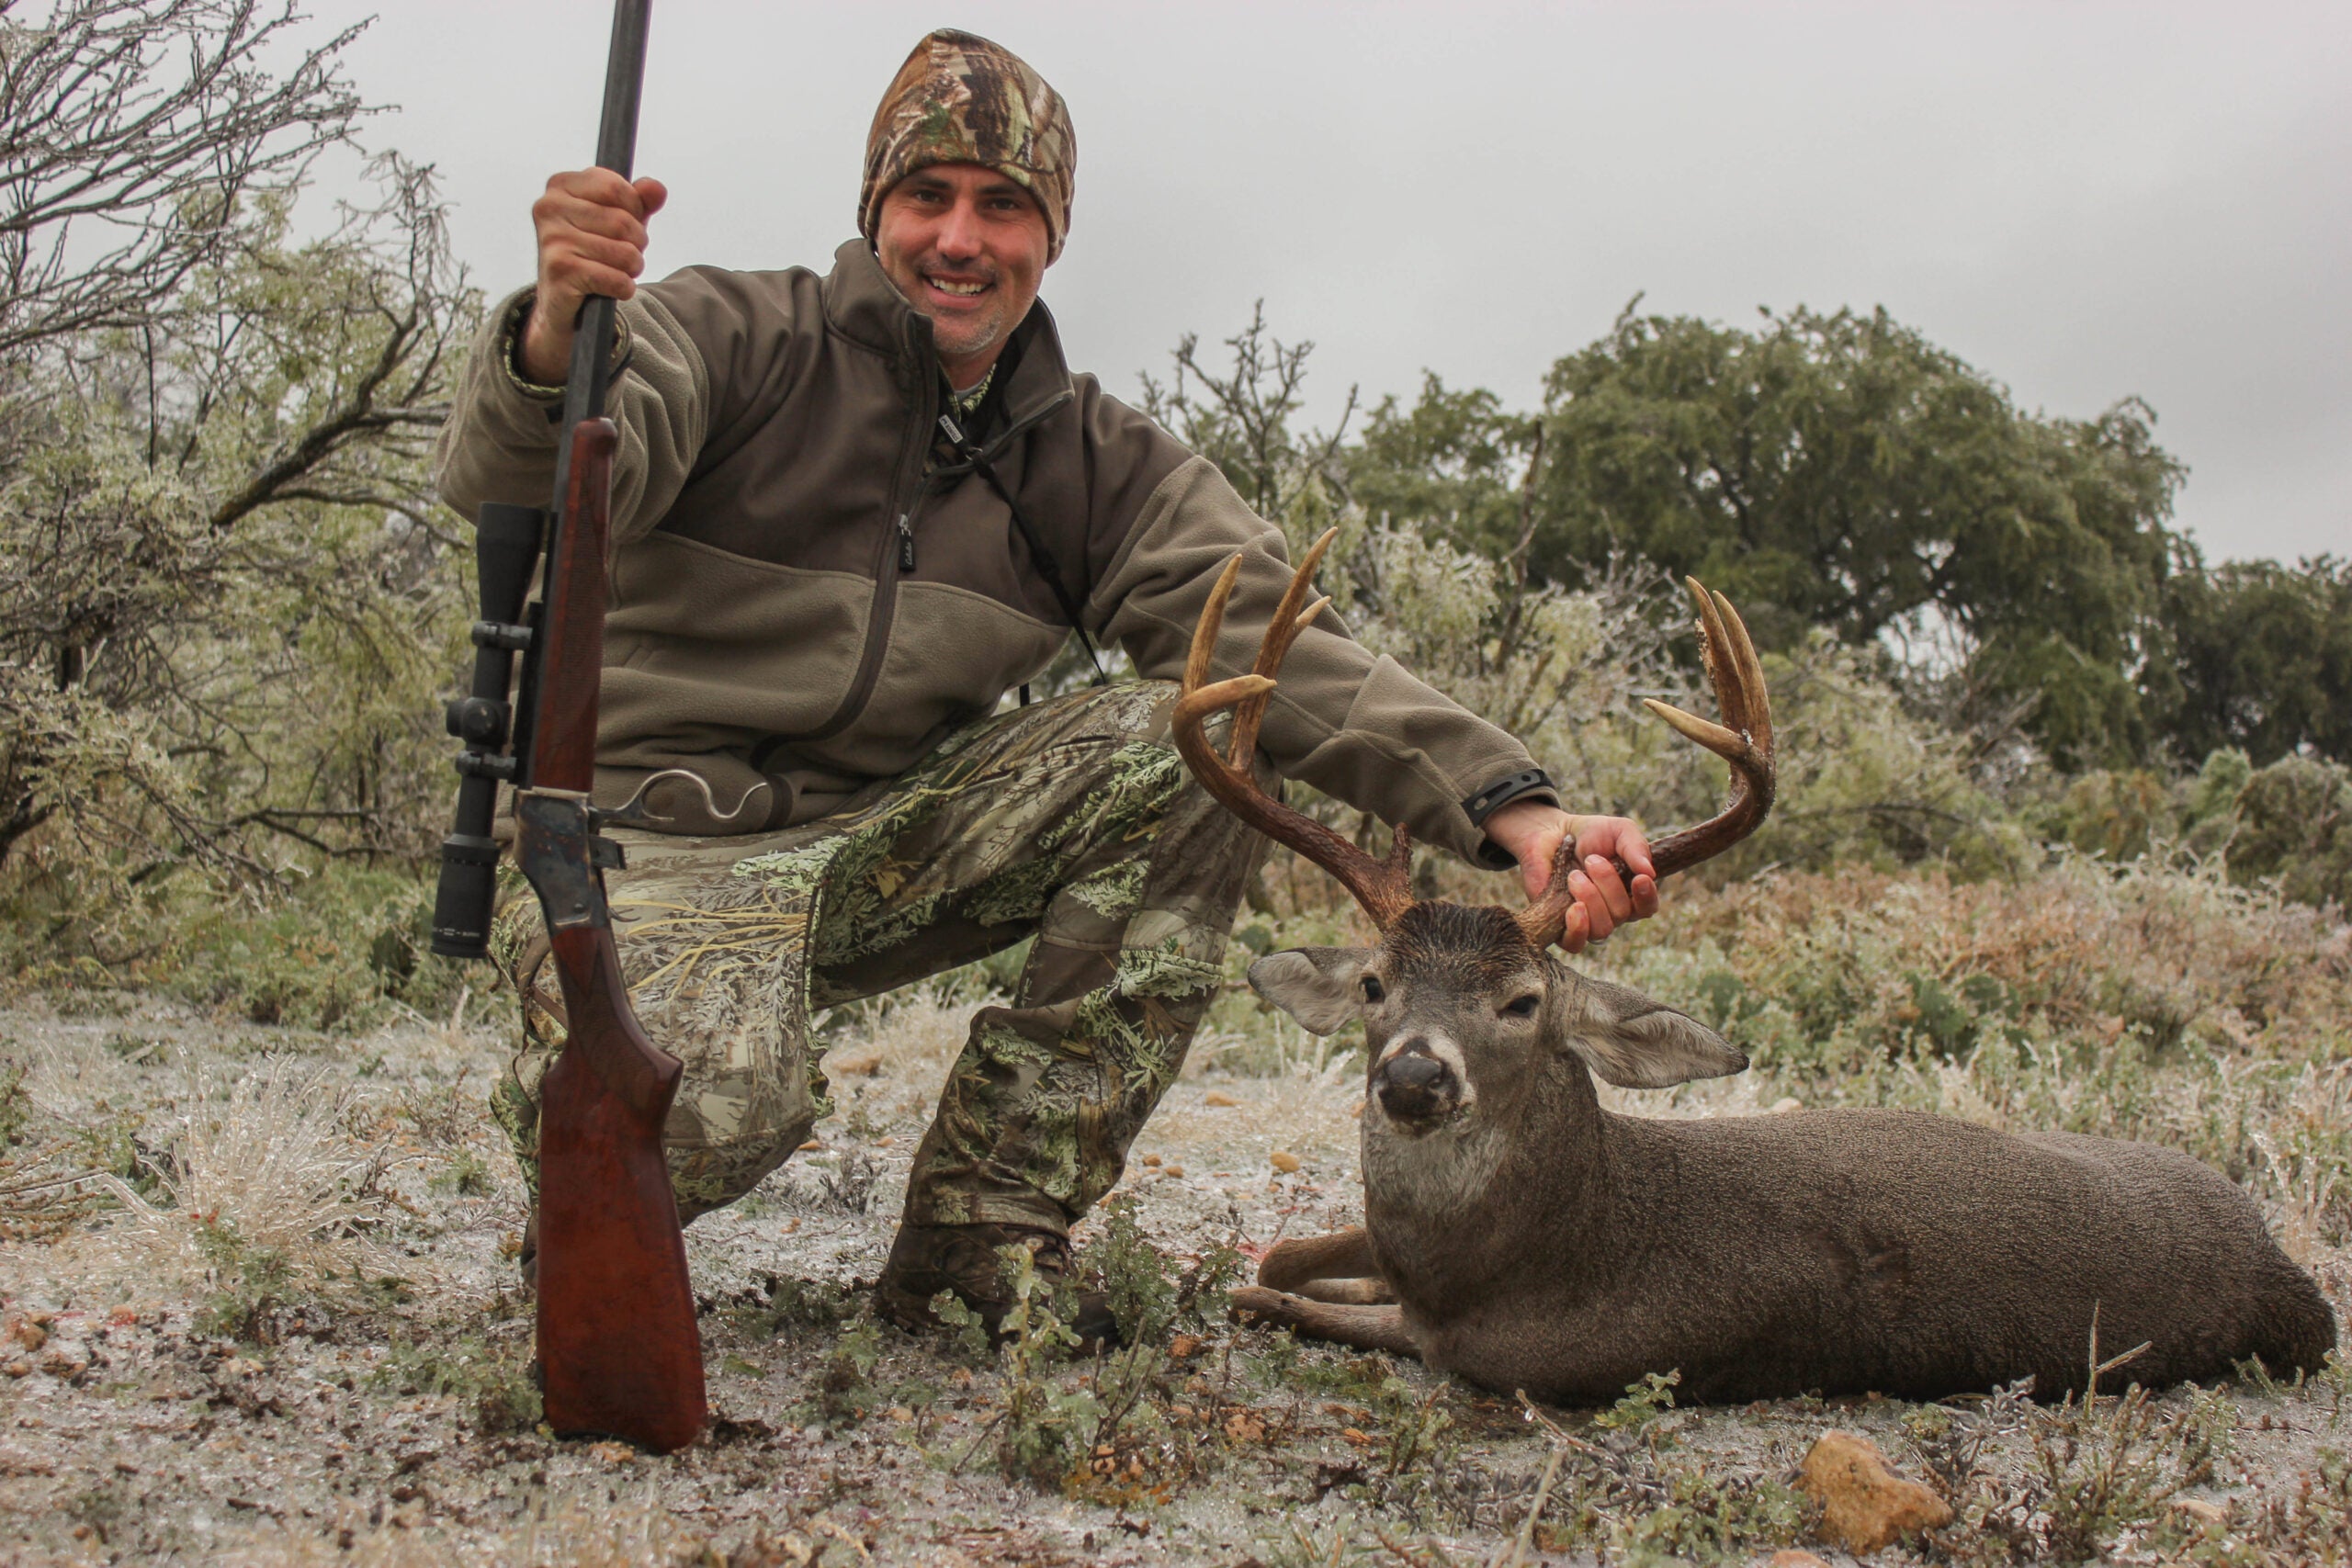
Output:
[{"xmin": 1532, "ymin": 306, "xmax": 2183, "ymax": 764}]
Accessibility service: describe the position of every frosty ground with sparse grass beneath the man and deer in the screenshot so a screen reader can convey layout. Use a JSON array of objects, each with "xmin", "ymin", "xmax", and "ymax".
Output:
[{"xmin": 0, "ymin": 893, "xmax": 2352, "ymax": 1568}]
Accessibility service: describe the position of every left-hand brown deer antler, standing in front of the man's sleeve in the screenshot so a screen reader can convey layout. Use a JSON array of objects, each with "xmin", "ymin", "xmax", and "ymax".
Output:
[{"xmin": 1171, "ymin": 529, "xmax": 1414, "ymax": 931}]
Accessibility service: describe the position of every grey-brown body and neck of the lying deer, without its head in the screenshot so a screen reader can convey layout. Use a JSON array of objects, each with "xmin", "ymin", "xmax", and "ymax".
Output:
[{"xmin": 1345, "ymin": 982, "xmax": 2335, "ymax": 1404}]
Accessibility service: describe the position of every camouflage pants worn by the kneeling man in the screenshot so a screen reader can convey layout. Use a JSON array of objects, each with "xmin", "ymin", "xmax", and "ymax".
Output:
[{"xmin": 492, "ymin": 682, "xmax": 1265, "ymax": 1232}]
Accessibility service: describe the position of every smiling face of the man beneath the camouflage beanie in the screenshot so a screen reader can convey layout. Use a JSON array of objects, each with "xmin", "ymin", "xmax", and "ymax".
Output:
[{"xmin": 875, "ymin": 163, "xmax": 1046, "ymax": 386}]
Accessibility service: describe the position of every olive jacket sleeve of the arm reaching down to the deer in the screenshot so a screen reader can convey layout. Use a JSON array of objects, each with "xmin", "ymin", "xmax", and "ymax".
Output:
[{"xmin": 1087, "ymin": 456, "xmax": 1557, "ymax": 870}]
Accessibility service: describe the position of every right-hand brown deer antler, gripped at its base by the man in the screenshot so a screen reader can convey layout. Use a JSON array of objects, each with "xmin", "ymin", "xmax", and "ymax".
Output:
[{"xmin": 1520, "ymin": 579, "xmax": 1773, "ymax": 947}]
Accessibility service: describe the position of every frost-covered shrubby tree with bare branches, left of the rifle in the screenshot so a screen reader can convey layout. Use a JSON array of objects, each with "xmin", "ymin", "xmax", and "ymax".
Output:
[{"xmin": 0, "ymin": 0, "xmax": 480, "ymax": 952}]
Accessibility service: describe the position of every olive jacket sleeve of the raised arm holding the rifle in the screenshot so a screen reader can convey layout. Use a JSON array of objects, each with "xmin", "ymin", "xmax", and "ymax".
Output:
[{"xmin": 433, "ymin": 289, "xmax": 710, "ymax": 543}]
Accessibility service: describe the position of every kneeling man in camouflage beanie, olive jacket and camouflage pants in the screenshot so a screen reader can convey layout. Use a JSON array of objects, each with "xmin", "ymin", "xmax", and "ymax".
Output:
[{"xmin": 440, "ymin": 30, "xmax": 1658, "ymax": 1328}]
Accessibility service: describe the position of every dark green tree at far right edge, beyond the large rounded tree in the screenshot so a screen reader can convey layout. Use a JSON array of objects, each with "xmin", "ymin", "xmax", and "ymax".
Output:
[{"xmin": 2141, "ymin": 555, "xmax": 2352, "ymax": 766}]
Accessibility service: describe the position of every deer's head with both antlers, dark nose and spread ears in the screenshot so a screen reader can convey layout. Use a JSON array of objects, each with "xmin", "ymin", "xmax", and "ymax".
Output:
[{"xmin": 1173, "ymin": 529, "xmax": 1773, "ymax": 1135}]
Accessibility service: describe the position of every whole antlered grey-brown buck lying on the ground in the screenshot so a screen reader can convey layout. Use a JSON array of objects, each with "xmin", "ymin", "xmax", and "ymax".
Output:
[{"xmin": 1173, "ymin": 534, "xmax": 2335, "ymax": 1405}]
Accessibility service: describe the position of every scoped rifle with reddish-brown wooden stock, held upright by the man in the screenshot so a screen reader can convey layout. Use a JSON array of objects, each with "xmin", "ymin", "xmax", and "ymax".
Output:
[{"xmin": 433, "ymin": 0, "xmax": 706, "ymax": 1453}]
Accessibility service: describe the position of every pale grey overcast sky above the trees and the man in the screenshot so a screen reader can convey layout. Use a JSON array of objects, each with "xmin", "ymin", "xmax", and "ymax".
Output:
[{"xmin": 326, "ymin": 0, "xmax": 2352, "ymax": 558}]
